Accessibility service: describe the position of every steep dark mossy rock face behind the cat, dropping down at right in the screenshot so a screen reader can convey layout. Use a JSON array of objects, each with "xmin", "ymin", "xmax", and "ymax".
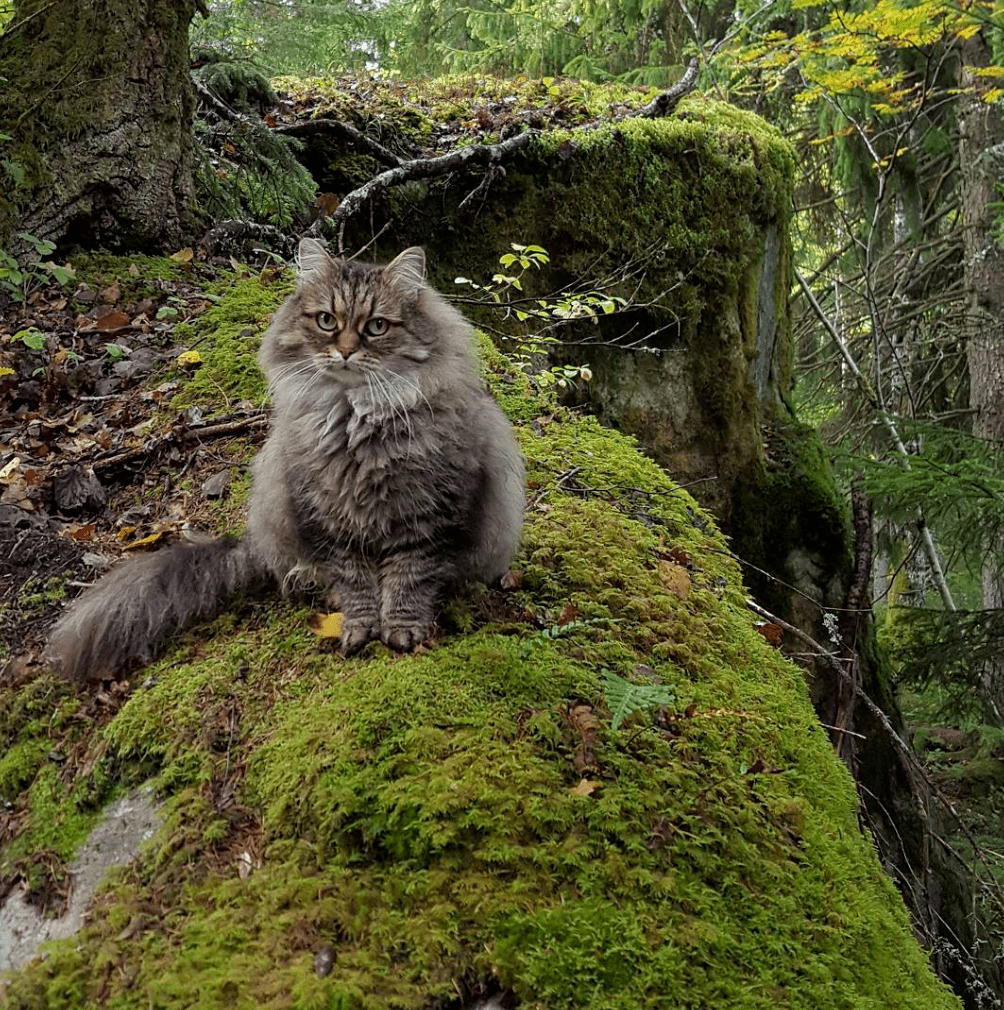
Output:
[{"xmin": 300, "ymin": 78, "xmax": 1004, "ymax": 996}]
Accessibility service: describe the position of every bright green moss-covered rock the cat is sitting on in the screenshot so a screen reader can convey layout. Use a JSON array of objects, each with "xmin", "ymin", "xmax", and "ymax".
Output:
[{"xmin": 0, "ymin": 272, "xmax": 959, "ymax": 1010}]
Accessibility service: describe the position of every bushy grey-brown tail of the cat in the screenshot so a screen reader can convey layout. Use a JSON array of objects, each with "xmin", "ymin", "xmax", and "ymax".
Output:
[{"xmin": 46, "ymin": 538, "xmax": 264, "ymax": 681}]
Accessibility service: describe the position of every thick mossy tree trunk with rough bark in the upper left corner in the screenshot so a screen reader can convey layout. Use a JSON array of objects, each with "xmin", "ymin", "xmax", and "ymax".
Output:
[{"xmin": 0, "ymin": 0, "xmax": 196, "ymax": 250}]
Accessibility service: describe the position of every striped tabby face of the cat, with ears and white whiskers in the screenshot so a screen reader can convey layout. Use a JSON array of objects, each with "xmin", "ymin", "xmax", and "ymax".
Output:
[{"xmin": 272, "ymin": 238, "xmax": 431, "ymax": 386}]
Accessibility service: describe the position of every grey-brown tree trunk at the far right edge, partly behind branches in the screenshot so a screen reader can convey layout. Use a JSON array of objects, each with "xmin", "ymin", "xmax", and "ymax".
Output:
[{"xmin": 959, "ymin": 33, "xmax": 1004, "ymax": 712}]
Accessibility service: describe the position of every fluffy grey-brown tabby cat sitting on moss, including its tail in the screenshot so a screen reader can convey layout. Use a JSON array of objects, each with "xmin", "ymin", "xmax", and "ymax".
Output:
[{"xmin": 47, "ymin": 238, "xmax": 524, "ymax": 681}]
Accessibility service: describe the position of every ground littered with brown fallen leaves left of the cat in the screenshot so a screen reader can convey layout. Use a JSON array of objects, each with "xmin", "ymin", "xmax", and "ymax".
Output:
[{"xmin": 0, "ymin": 250, "xmax": 265, "ymax": 679}]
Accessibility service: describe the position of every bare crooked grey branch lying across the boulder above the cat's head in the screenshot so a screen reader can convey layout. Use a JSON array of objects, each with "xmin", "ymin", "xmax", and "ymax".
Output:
[{"xmin": 325, "ymin": 59, "xmax": 698, "ymax": 255}]
